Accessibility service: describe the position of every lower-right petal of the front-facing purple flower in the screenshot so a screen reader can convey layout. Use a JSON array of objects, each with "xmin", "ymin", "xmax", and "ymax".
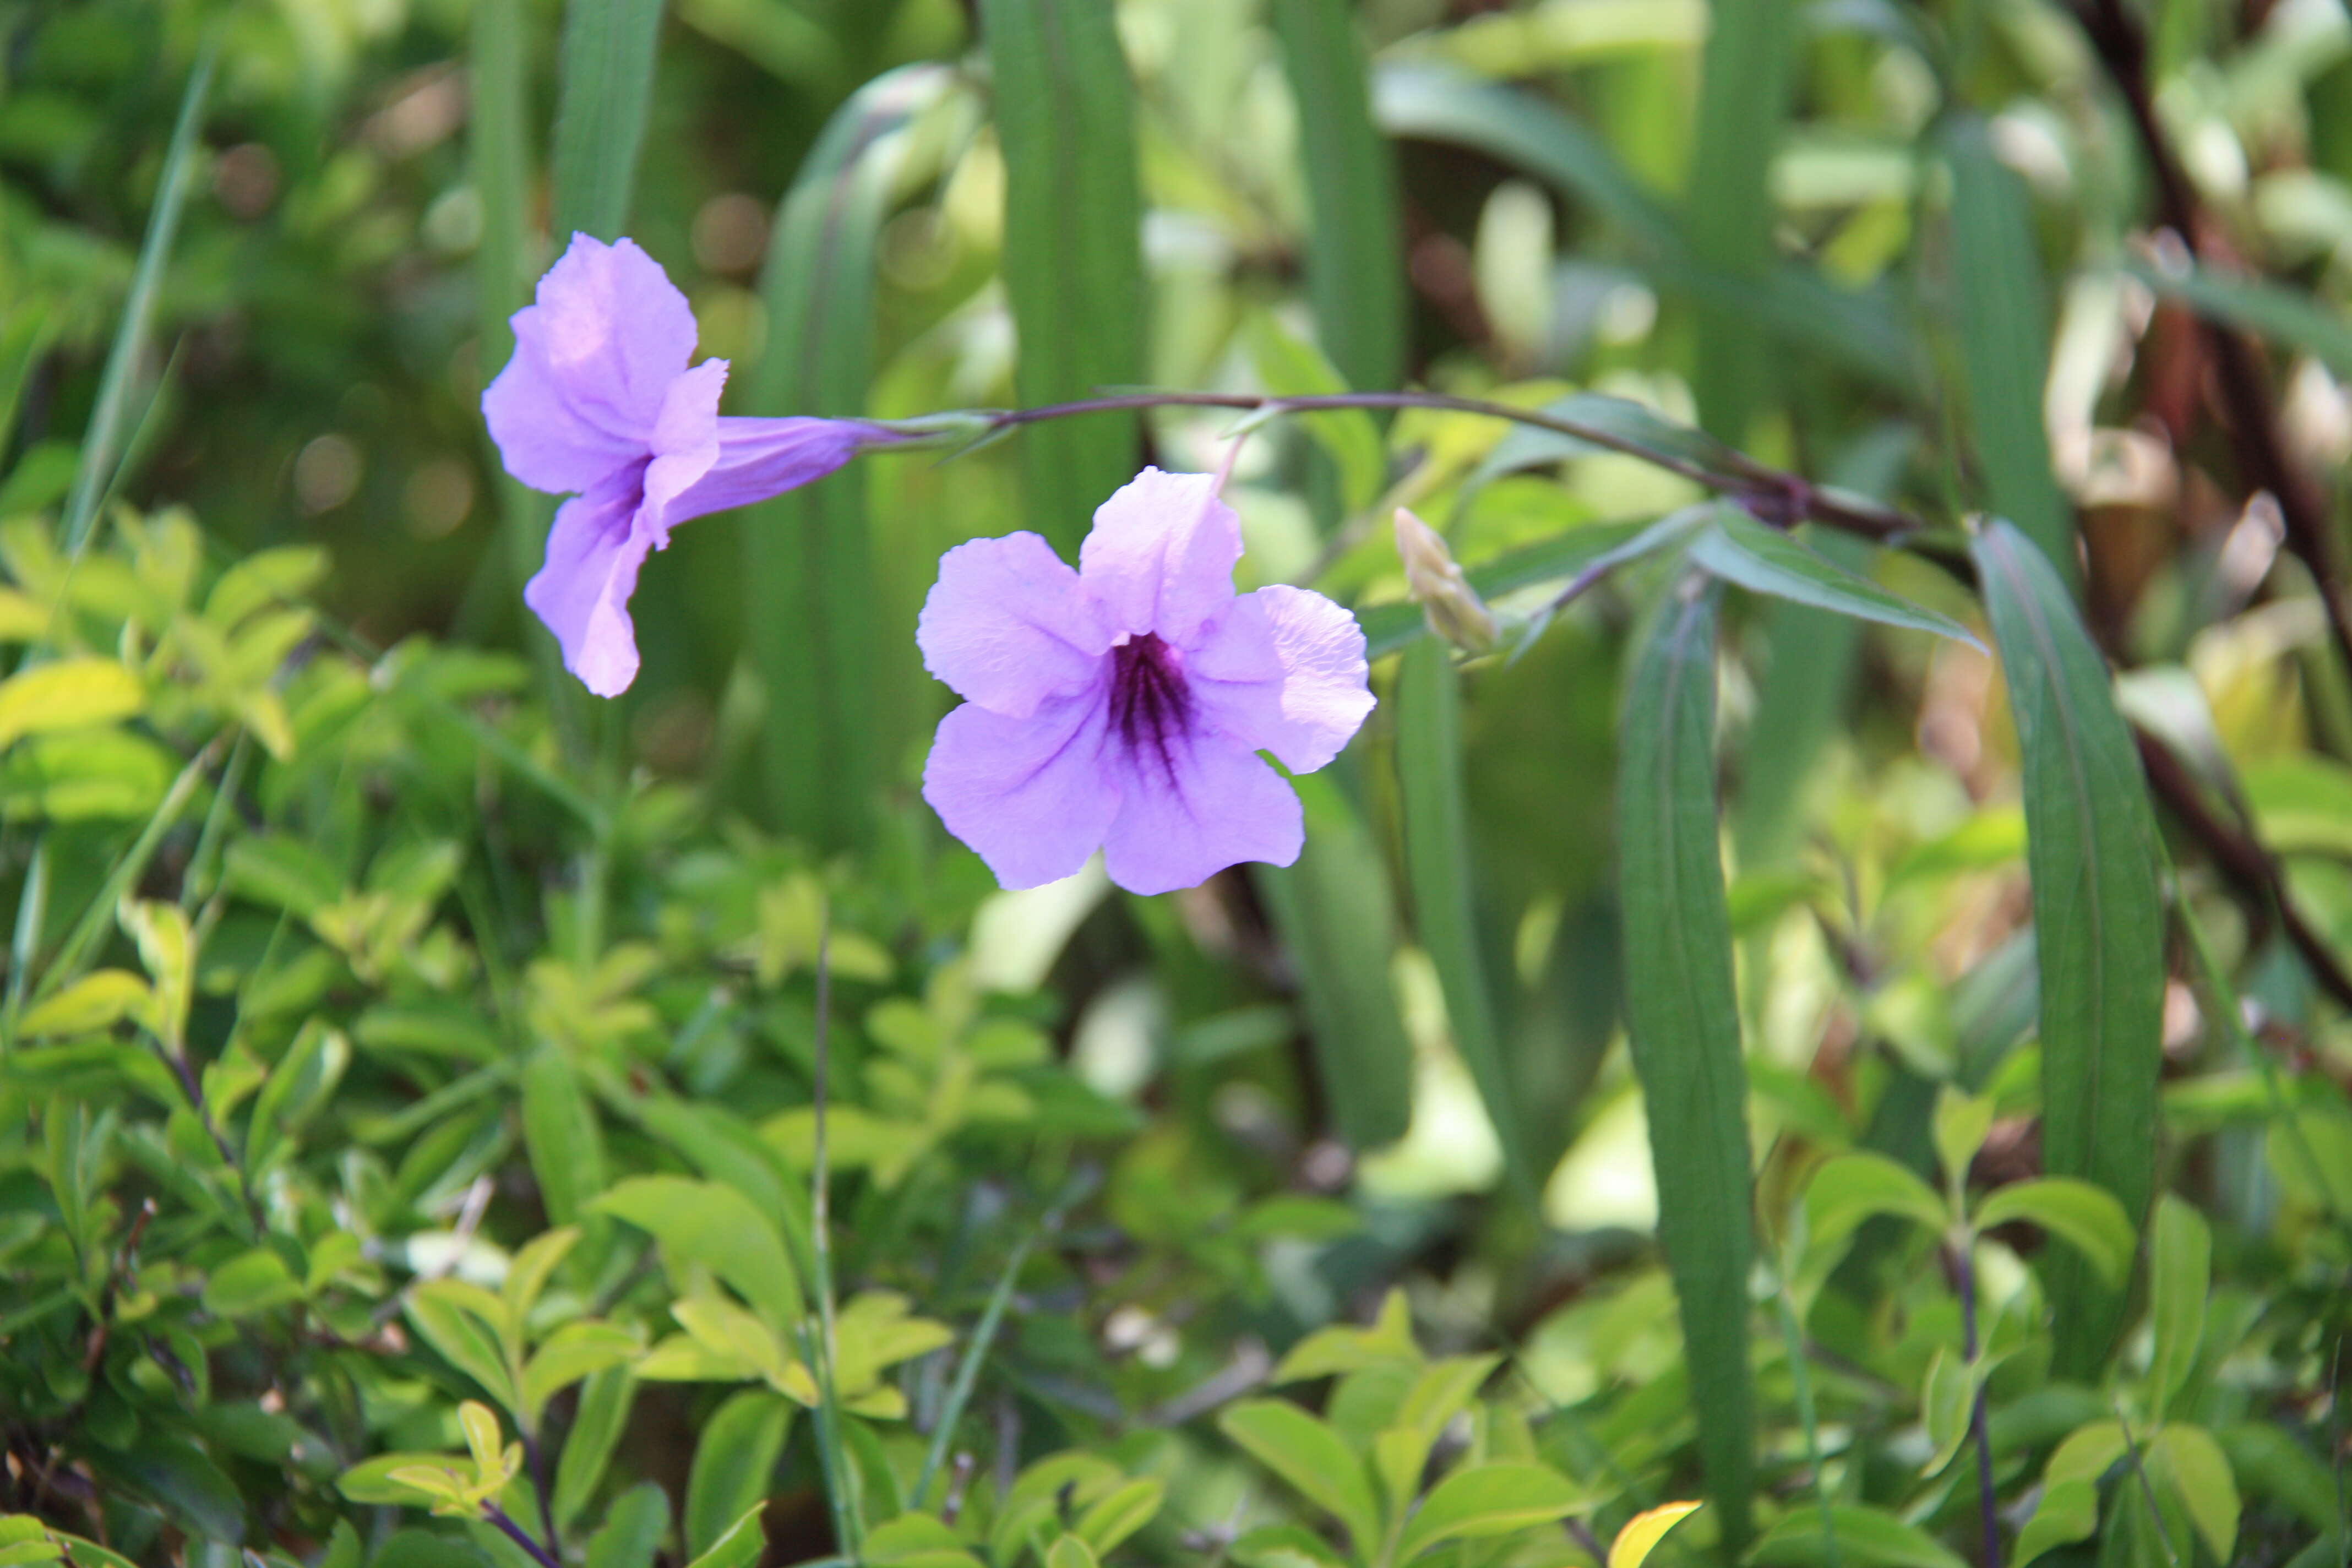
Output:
[{"xmin": 1103, "ymin": 731, "xmax": 1305, "ymax": 894}]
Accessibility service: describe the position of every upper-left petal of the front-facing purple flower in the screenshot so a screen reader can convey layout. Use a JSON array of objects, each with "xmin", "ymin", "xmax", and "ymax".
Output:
[{"xmin": 915, "ymin": 531, "xmax": 1110, "ymax": 720}]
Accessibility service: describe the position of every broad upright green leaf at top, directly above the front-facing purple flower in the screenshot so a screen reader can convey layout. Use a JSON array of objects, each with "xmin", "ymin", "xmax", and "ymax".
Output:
[{"xmin": 981, "ymin": 0, "xmax": 1148, "ymax": 557}]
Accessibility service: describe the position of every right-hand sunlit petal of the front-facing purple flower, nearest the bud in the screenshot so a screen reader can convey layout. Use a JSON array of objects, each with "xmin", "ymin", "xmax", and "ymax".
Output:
[{"xmin": 1185, "ymin": 585, "xmax": 1374, "ymax": 774}]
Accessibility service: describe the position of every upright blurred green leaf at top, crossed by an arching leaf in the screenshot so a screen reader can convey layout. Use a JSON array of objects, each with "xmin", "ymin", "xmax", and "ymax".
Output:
[{"xmin": 1689, "ymin": 0, "xmax": 1797, "ymax": 442}]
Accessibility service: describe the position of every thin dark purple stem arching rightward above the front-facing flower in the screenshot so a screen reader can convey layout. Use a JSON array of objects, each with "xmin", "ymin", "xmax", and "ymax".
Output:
[{"xmin": 988, "ymin": 393, "xmax": 1926, "ymax": 543}]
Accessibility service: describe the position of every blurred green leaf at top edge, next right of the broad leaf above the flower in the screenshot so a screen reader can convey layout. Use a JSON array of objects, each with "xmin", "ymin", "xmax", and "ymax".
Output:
[{"xmin": 1272, "ymin": 0, "xmax": 1404, "ymax": 390}]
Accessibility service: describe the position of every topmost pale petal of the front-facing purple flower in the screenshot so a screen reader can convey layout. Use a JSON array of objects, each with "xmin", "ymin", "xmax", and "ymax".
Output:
[{"xmin": 1077, "ymin": 468, "xmax": 1242, "ymax": 646}]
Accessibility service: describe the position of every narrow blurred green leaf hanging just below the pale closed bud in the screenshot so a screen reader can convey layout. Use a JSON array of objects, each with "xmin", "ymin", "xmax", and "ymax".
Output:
[{"xmin": 1397, "ymin": 637, "xmax": 1538, "ymax": 1204}]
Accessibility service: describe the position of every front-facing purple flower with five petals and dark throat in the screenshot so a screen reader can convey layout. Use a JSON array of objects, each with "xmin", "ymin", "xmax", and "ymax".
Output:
[{"xmin": 915, "ymin": 468, "xmax": 1371, "ymax": 894}]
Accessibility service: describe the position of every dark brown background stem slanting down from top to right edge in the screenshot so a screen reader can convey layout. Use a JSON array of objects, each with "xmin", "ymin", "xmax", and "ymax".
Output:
[{"xmin": 2075, "ymin": 0, "xmax": 2352, "ymax": 672}]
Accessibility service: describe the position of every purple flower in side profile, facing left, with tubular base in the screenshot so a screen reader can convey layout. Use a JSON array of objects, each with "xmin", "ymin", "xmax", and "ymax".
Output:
[{"xmin": 482, "ymin": 235, "xmax": 891, "ymax": 696}]
